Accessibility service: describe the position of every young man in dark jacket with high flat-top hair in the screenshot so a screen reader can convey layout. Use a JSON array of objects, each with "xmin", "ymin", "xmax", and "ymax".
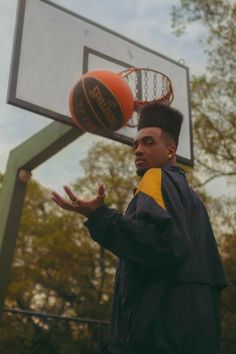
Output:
[{"xmin": 53, "ymin": 104, "xmax": 226, "ymax": 354}]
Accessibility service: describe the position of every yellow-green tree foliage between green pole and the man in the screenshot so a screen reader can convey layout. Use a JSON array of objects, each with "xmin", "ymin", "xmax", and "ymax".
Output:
[{"xmin": 0, "ymin": 143, "xmax": 137, "ymax": 354}]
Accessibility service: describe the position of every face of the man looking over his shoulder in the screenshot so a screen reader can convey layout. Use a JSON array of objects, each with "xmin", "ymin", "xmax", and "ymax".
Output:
[{"xmin": 133, "ymin": 127, "xmax": 175, "ymax": 176}]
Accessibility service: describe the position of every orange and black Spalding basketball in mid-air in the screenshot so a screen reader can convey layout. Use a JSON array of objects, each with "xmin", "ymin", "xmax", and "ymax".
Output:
[{"xmin": 69, "ymin": 70, "xmax": 134, "ymax": 133}]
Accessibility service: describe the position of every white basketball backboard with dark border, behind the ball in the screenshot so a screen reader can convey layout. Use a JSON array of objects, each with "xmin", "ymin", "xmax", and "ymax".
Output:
[{"xmin": 8, "ymin": 0, "xmax": 193, "ymax": 165}]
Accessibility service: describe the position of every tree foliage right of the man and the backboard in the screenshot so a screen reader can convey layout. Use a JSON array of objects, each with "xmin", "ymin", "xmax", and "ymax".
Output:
[{"xmin": 172, "ymin": 0, "xmax": 236, "ymax": 354}]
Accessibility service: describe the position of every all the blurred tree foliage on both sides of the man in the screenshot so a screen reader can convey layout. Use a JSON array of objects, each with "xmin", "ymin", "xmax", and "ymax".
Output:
[{"xmin": 0, "ymin": 0, "xmax": 236, "ymax": 354}]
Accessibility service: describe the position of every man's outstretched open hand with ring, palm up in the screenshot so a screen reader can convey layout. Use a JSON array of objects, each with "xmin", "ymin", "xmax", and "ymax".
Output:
[{"xmin": 51, "ymin": 184, "xmax": 105, "ymax": 217}]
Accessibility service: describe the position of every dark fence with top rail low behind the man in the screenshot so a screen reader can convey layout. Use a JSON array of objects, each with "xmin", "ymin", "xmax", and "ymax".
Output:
[{"xmin": 0, "ymin": 308, "xmax": 236, "ymax": 354}]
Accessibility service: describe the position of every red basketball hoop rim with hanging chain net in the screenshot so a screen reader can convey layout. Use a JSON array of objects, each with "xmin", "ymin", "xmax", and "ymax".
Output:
[{"xmin": 120, "ymin": 68, "xmax": 174, "ymax": 127}]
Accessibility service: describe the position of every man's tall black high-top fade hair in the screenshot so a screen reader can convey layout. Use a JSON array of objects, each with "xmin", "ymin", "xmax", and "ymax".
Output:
[{"xmin": 138, "ymin": 103, "xmax": 183, "ymax": 147}]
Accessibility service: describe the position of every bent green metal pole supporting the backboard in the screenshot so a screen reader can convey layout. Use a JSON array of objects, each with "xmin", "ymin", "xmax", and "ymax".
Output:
[{"xmin": 0, "ymin": 122, "xmax": 84, "ymax": 313}]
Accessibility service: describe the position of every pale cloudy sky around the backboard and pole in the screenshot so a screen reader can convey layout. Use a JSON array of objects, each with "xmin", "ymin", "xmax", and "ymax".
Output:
[{"xmin": 0, "ymin": 0, "xmax": 230, "ymax": 193}]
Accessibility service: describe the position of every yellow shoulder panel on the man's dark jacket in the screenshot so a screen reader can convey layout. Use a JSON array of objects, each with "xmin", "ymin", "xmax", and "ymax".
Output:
[{"xmin": 135, "ymin": 168, "xmax": 166, "ymax": 209}]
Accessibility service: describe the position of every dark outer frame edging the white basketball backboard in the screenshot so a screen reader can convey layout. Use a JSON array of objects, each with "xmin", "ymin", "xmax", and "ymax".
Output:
[{"xmin": 7, "ymin": 0, "xmax": 194, "ymax": 166}]
